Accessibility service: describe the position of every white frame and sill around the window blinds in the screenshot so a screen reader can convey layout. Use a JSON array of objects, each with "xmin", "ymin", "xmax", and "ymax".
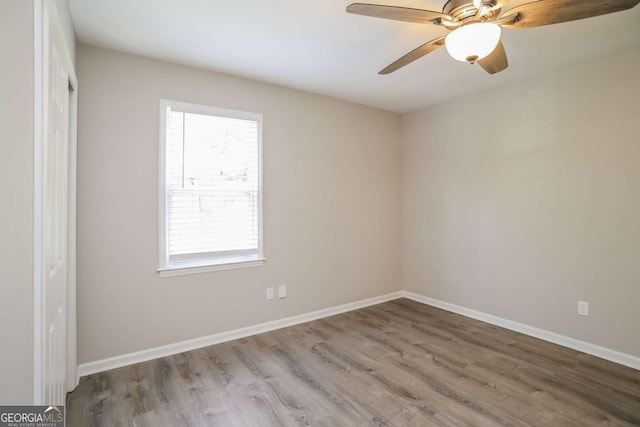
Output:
[{"xmin": 158, "ymin": 99, "xmax": 266, "ymax": 277}]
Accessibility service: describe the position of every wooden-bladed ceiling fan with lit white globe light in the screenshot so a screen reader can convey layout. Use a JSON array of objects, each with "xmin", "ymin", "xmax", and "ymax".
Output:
[{"xmin": 347, "ymin": 0, "xmax": 640, "ymax": 74}]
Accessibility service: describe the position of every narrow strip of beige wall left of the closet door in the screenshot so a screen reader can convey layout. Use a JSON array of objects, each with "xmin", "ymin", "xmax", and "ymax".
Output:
[{"xmin": 0, "ymin": 0, "xmax": 33, "ymax": 405}]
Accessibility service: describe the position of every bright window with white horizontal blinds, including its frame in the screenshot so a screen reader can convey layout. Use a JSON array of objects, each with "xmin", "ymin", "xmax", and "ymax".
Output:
[{"xmin": 159, "ymin": 100, "xmax": 264, "ymax": 276}]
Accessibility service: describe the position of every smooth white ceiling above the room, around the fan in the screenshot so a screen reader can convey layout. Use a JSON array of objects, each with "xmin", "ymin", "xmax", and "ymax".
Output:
[{"xmin": 69, "ymin": 0, "xmax": 640, "ymax": 112}]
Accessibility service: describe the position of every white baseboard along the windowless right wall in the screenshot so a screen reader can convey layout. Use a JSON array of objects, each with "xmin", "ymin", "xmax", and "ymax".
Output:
[{"xmin": 401, "ymin": 291, "xmax": 640, "ymax": 369}]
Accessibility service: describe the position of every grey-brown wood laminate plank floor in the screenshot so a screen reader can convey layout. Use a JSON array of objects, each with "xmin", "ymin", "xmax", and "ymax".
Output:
[{"xmin": 67, "ymin": 299, "xmax": 640, "ymax": 427}]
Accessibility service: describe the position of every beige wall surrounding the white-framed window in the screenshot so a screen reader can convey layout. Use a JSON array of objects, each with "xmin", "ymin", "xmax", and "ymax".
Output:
[{"xmin": 77, "ymin": 45, "xmax": 401, "ymax": 363}]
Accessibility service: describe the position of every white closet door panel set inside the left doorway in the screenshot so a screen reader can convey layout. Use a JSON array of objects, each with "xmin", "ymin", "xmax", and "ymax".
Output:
[{"xmin": 43, "ymin": 8, "xmax": 69, "ymax": 405}]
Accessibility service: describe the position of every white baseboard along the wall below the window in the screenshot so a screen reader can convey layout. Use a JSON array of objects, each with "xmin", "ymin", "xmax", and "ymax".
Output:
[{"xmin": 78, "ymin": 291, "xmax": 402, "ymax": 377}]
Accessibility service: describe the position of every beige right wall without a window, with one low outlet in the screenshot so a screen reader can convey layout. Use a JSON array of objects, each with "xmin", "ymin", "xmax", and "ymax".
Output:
[{"xmin": 403, "ymin": 49, "xmax": 640, "ymax": 356}]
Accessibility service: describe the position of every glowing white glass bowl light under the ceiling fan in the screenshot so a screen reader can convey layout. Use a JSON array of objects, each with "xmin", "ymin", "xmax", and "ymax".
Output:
[{"xmin": 444, "ymin": 22, "xmax": 501, "ymax": 64}]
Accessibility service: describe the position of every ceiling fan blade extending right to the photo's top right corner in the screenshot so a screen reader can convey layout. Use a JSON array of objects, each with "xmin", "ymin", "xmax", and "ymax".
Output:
[{"xmin": 503, "ymin": 0, "xmax": 640, "ymax": 28}]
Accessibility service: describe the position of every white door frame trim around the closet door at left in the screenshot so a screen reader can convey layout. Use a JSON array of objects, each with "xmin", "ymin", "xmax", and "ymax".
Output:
[{"xmin": 33, "ymin": 0, "xmax": 79, "ymax": 405}]
